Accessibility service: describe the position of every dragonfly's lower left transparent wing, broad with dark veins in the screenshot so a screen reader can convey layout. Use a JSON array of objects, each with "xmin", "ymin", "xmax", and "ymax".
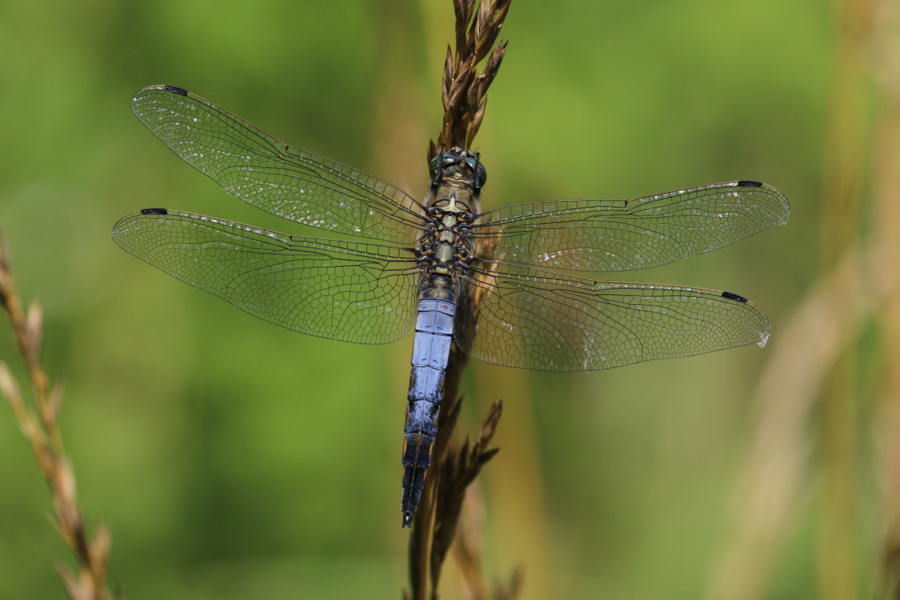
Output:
[{"xmin": 112, "ymin": 209, "xmax": 420, "ymax": 344}]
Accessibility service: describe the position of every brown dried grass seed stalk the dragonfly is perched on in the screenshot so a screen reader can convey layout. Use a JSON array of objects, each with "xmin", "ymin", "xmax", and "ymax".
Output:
[{"xmin": 404, "ymin": 0, "xmax": 520, "ymax": 599}]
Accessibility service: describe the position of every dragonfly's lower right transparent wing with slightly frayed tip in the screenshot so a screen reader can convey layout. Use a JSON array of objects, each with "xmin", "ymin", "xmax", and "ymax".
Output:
[{"xmin": 456, "ymin": 264, "xmax": 769, "ymax": 371}]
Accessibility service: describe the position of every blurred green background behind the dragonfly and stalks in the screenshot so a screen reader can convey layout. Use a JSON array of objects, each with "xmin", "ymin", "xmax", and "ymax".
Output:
[{"xmin": 0, "ymin": 0, "xmax": 884, "ymax": 600}]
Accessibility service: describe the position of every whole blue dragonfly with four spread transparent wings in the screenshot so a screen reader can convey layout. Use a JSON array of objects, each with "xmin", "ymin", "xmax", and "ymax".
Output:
[{"xmin": 112, "ymin": 85, "xmax": 790, "ymax": 527}]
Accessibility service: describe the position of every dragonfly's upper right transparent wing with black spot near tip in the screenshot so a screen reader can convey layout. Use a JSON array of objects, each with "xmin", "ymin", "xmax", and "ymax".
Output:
[{"xmin": 472, "ymin": 181, "xmax": 790, "ymax": 272}]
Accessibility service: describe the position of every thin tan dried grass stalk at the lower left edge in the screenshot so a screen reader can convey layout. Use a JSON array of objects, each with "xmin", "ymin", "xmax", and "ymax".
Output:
[{"xmin": 0, "ymin": 242, "xmax": 111, "ymax": 600}]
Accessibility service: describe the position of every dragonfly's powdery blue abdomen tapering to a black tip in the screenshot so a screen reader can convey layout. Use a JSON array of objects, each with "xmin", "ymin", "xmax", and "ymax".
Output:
[{"xmin": 402, "ymin": 298, "xmax": 456, "ymax": 527}]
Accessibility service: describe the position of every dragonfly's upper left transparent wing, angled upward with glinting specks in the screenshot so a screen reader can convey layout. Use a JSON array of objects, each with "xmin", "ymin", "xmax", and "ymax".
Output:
[{"xmin": 131, "ymin": 86, "xmax": 422, "ymax": 244}]
